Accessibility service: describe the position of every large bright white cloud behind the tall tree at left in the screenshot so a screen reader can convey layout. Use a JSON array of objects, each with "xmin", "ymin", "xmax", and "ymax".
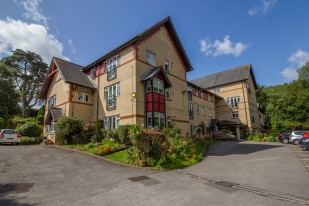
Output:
[{"xmin": 0, "ymin": 18, "xmax": 69, "ymax": 64}]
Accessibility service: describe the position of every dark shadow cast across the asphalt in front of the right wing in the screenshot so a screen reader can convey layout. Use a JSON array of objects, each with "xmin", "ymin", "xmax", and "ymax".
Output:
[{"xmin": 207, "ymin": 142, "xmax": 284, "ymax": 156}]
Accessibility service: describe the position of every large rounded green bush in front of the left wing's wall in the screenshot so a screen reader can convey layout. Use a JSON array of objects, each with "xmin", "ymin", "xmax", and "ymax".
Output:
[{"xmin": 55, "ymin": 117, "xmax": 83, "ymax": 145}]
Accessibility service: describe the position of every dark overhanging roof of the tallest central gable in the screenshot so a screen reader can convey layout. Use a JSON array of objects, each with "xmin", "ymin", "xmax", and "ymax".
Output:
[{"xmin": 83, "ymin": 16, "xmax": 193, "ymax": 72}]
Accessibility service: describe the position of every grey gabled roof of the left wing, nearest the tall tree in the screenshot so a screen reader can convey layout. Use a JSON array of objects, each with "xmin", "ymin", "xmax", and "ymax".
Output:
[{"xmin": 39, "ymin": 57, "xmax": 97, "ymax": 99}]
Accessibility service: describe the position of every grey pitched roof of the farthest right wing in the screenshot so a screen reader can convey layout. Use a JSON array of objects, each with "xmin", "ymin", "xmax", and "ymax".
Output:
[{"xmin": 190, "ymin": 64, "xmax": 257, "ymax": 89}]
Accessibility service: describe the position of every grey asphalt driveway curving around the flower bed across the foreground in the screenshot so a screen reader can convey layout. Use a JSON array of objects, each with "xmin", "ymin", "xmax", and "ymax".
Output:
[{"xmin": 0, "ymin": 142, "xmax": 309, "ymax": 206}]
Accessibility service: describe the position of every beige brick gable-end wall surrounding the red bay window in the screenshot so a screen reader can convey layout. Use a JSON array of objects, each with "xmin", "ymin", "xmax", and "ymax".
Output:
[{"xmin": 136, "ymin": 26, "xmax": 189, "ymax": 134}]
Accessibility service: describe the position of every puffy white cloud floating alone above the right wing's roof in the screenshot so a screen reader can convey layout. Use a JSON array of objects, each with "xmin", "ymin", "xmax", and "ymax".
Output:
[{"xmin": 200, "ymin": 35, "xmax": 249, "ymax": 57}]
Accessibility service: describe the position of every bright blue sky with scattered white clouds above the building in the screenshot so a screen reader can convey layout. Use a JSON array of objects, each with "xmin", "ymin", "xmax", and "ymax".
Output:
[{"xmin": 0, "ymin": 0, "xmax": 309, "ymax": 86}]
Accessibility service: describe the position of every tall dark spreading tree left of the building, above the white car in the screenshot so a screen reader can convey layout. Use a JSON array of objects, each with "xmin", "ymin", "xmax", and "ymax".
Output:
[{"xmin": 1, "ymin": 49, "xmax": 48, "ymax": 117}]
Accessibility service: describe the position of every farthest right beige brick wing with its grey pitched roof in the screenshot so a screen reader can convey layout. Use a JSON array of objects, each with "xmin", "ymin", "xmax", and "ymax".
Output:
[{"xmin": 191, "ymin": 64, "xmax": 261, "ymax": 136}]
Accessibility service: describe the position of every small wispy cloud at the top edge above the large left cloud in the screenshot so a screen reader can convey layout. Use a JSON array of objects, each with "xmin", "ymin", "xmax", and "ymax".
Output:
[{"xmin": 15, "ymin": 0, "xmax": 48, "ymax": 29}]
